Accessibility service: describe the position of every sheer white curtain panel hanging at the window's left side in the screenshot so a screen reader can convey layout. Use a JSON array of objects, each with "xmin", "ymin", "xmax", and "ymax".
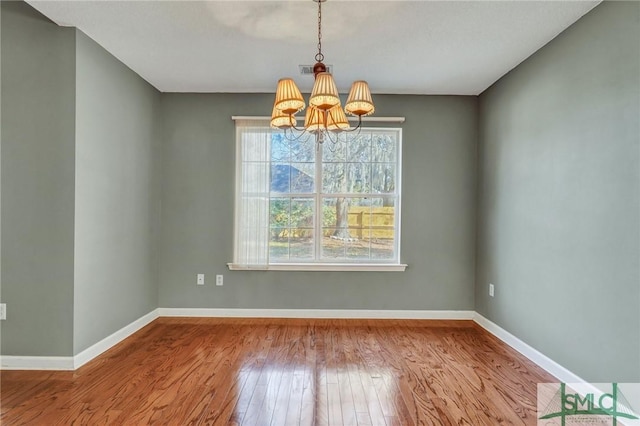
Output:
[{"xmin": 233, "ymin": 119, "xmax": 271, "ymax": 269}]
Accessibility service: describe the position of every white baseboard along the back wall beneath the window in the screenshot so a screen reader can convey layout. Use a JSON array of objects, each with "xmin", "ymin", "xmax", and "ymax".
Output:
[{"xmin": 158, "ymin": 308, "xmax": 475, "ymax": 320}]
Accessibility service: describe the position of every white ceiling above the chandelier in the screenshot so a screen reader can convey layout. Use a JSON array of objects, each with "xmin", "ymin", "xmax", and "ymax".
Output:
[{"xmin": 28, "ymin": 0, "xmax": 599, "ymax": 95}]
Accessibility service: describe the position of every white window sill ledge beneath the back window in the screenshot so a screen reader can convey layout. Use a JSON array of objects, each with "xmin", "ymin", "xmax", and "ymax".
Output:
[{"xmin": 227, "ymin": 263, "xmax": 407, "ymax": 272}]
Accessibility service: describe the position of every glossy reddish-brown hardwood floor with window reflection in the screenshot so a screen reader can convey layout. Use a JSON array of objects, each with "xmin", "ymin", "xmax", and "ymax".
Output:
[{"xmin": 0, "ymin": 318, "xmax": 556, "ymax": 426}]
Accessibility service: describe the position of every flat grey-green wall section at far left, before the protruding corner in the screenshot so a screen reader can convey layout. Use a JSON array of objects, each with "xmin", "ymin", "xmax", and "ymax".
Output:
[{"xmin": 0, "ymin": 1, "xmax": 75, "ymax": 356}]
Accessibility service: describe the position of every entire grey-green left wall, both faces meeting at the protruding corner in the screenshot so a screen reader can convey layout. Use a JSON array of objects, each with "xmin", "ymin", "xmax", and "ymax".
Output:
[{"xmin": 0, "ymin": 1, "xmax": 161, "ymax": 356}]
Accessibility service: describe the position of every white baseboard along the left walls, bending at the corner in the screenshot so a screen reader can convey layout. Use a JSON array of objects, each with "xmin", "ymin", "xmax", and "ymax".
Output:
[{"xmin": 0, "ymin": 309, "xmax": 158, "ymax": 371}]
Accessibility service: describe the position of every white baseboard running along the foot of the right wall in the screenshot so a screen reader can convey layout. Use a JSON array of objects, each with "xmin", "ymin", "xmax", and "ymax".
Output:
[{"xmin": 473, "ymin": 312, "xmax": 586, "ymax": 383}]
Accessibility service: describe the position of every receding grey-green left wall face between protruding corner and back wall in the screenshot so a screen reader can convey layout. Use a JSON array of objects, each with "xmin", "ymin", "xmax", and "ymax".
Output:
[{"xmin": 73, "ymin": 31, "xmax": 161, "ymax": 353}]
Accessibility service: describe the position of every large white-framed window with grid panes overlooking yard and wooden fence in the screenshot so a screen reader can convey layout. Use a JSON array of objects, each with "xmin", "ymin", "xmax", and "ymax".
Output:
[{"xmin": 229, "ymin": 120, "xmax": 405, "ymax": 270}]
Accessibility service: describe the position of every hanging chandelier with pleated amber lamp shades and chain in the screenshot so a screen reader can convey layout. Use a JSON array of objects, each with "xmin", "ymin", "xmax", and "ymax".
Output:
[{"xmin": 271, "ymin": 0, "xmax": 375, "ymax": 143}]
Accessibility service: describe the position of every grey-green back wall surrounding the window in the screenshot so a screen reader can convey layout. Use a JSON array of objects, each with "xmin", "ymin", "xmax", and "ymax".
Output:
[{"xmin": 159, "ymin": 94, "xmax": 477, "ymax": 310}]
